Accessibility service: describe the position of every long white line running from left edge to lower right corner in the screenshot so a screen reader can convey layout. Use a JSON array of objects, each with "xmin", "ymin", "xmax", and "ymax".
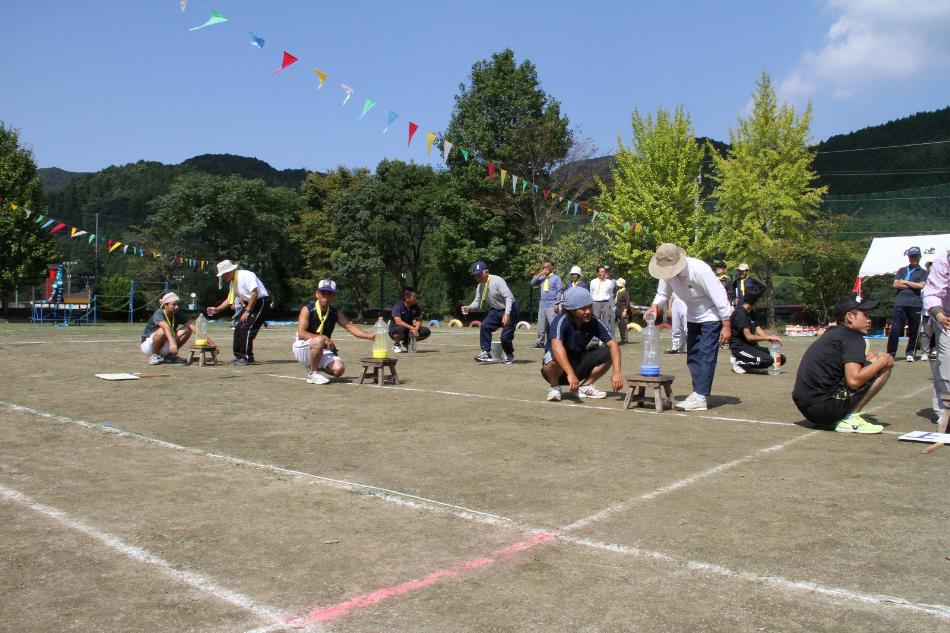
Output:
[{"xmin": 0, "ymin": 402, "xmax": 950, "ymax": 620}]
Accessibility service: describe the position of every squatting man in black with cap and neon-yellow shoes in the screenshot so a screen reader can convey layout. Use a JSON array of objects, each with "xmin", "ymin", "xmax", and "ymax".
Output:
[{"xmin": 792, "ymin": 297, "xmax": 894, "ymax": 433}]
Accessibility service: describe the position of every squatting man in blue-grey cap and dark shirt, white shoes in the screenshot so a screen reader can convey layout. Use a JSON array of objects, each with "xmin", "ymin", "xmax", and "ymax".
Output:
[{"xmin": 541, "ymin": 288, "xmax": 623, "ymax": 400}]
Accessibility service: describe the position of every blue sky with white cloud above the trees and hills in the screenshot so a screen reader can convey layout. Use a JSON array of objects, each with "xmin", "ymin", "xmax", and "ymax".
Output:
[{"xmin": 0, "ymin": 0, "xmax": 950, "ymax": 171}]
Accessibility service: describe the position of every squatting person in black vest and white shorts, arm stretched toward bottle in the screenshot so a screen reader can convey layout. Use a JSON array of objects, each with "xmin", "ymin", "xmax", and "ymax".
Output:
[{"xmin": 293, "ymin": 279, "xmax": 376, "ymax": 385}]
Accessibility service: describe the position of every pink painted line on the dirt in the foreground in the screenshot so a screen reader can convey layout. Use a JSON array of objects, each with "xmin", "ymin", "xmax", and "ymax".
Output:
[{"xmin": 287, "ymin": 532, "xmax": 557, "ymax": 627}]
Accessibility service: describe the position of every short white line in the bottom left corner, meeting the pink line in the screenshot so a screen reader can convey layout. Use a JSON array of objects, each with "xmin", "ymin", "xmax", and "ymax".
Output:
[{"xmin": 0, "ymin": 484, "xmax": 287, "ymax": 625}]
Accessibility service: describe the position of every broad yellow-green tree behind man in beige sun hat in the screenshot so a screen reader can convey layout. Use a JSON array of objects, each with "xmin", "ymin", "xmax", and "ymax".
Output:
[{"xmin": 598, "ymin": 107, "xmax": 708, "ymax": 275}]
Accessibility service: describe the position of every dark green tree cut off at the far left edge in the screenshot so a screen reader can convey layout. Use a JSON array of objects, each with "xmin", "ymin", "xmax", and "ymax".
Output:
[{"xmin": 0, "ymin": 123, "xmax": 60, "ymax": 314}]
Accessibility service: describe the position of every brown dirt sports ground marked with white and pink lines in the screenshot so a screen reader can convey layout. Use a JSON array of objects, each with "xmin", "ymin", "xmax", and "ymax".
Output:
[{"xmin": 0, "ymin": 324, "xmax": 950, "ymax": 633}]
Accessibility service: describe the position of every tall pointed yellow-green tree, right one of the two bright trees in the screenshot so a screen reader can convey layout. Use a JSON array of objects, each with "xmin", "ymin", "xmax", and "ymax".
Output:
[{"xmin": 713, "ymin": 72, "xmax": 826, "ymax": 324}]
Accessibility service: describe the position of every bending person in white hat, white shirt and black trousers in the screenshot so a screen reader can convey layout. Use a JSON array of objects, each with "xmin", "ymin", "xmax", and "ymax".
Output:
[{"xmin": 208, "ymin": 259, "xmax": 270, "ymax": 365}]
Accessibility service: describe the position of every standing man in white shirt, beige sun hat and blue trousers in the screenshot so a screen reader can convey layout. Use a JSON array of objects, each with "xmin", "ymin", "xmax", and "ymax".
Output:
[{"xmin": 647, "ymin": 244, "xmax": 732, "ymax": 411}]
